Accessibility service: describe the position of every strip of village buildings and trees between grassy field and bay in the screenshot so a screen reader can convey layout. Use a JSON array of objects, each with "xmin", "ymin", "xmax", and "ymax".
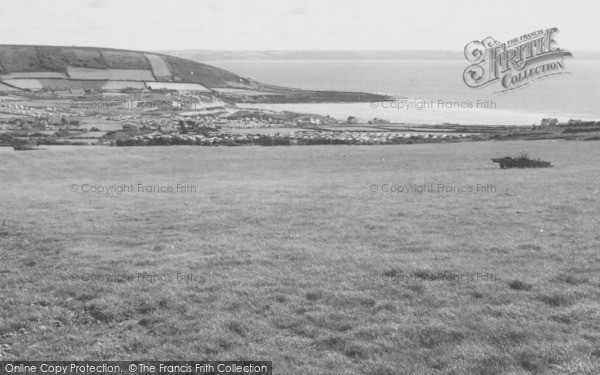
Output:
[{"xmin": 0, "ymin": 90, "xmax": 598, "ymax": 148}]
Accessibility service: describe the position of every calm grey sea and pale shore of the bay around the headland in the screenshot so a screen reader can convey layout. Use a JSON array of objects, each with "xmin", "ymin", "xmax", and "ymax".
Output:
[{"xmin": 203, "ymin": 58, "xmax": 600, "ymax": 125}]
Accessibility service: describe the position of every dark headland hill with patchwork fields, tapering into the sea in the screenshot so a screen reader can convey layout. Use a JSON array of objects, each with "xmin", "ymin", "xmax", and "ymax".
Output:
[{"xmin": 0, "ymin": 45, "xmax": 386, "ymax": 103}]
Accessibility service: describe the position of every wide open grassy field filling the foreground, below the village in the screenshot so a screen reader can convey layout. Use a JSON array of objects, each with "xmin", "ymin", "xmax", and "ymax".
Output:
[{"xmin": 0, "ymin": 141, "xmax": 600, "ymax": 375}]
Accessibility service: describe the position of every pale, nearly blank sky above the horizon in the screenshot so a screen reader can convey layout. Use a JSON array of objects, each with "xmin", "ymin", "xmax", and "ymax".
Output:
[{"xmin": 0, "ymin": 0, "xmax": 600, "ymax": 51}]
